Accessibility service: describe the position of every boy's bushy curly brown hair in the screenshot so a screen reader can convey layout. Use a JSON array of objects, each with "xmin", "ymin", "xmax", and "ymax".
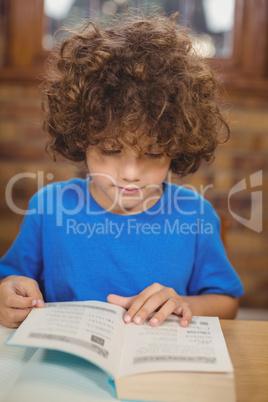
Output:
[{"xmin": 43, "ymin": 14, "xmax": 229, "ymax": 176}]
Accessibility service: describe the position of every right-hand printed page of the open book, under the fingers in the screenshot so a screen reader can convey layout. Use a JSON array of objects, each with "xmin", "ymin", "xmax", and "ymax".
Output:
[{"xmin": 116, "ymin": 315, "xmax": 233, "ymax": 378}]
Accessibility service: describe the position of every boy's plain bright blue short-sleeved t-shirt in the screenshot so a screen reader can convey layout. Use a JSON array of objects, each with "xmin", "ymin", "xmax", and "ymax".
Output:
[{"xmin": 0, "ymin": 179, "xmax": 243, "ymax": 302}]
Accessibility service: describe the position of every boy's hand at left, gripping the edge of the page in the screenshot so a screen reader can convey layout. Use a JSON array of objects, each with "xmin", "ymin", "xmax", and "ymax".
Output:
[{"xmin": 0, "ymin": 275, "xmax": 45, "ymax": 328}]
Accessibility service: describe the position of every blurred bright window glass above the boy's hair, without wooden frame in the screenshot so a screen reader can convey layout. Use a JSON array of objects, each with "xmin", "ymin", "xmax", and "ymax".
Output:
[{"xmin": 42, "ymin": 0, "xmax": 235, "ymax": 58}]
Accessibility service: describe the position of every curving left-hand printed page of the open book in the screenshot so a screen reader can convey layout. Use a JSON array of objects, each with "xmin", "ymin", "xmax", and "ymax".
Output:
[{"xmin": 7, "ymin": 301, "xmax": 125, "ymax": 376}]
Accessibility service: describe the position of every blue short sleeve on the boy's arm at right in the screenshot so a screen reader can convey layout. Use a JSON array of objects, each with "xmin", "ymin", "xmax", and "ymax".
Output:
[{"xmin": 188, "ymin": 200, "xmax": 243, "ymax": 297}]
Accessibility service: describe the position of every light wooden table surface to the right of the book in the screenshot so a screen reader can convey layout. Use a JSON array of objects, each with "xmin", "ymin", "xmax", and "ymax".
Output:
[{"xmin": 220, "ymin": 320, "xmax": 268, "ymax": 402}]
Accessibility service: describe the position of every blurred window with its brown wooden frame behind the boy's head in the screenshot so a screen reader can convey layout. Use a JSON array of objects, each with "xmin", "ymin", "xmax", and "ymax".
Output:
[{"xmin": 0, "ymin": 0, "xmax": 268, "ymax": 96}]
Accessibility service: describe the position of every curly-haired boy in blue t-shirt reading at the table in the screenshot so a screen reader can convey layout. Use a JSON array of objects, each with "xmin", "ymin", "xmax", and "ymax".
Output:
[{"xmin": 0, "ymin": 15, "xmax": 243, "ymax": 327}]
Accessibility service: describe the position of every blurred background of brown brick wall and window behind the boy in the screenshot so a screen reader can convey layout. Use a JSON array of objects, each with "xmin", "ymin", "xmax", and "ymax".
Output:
[{"xmin": 0, "ymin": 0, "xmax": 268, "ymax": 319}]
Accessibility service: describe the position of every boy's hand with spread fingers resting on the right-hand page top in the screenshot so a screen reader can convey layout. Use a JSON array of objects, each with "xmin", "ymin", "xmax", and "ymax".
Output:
[{"xmin": 107, "ymin": 283, "xmax": 193, "ymax": 327}]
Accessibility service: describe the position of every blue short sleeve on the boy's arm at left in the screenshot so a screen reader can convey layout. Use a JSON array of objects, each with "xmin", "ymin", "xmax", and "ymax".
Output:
[{"xmin": 0, "ymin": 194, "xmax": 43, "ymax": 285}]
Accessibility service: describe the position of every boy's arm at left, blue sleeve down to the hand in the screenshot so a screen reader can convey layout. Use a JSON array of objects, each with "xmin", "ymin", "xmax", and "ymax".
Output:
[{"xmin": 0, "ymin": 192, "xmax": 47, "ymax": 328}]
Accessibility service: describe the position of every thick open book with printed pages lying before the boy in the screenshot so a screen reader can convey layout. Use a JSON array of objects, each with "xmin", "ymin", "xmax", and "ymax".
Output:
[{"xmin": 6, "ymin": 301, "xmax": 235, "ymax": 402}]
